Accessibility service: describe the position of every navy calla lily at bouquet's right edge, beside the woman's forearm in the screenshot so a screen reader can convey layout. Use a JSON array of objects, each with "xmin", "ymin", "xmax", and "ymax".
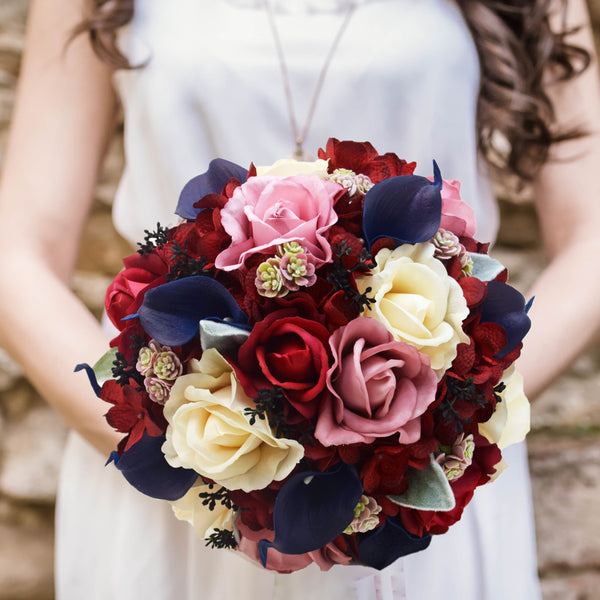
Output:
[{"xmin": 481, "ymin": 281, "xmax": 533, "ymax": 358}]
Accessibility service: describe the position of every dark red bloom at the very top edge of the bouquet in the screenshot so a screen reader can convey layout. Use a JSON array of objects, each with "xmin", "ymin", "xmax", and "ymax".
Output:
[{"xmin": 319, "ymin": 138, "xmax": 417, "ymax": 183}]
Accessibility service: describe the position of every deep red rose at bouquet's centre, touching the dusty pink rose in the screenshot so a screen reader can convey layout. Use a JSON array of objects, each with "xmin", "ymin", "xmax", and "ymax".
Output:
[{"xmin": 238, "ymin": 310, "xmax": 329, "ymax": 418}]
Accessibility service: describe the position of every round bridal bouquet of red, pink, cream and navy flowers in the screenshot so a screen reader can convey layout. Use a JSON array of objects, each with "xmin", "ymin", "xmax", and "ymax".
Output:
[{"xmin": 78, "ymin": 139, "xmax": 530, "ymax": 572}]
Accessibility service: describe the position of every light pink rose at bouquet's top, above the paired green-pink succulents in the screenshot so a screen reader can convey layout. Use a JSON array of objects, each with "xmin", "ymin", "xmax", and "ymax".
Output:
[{"xmin": 215, "ymin": 175, "xmax": 342, "ymax": 271}]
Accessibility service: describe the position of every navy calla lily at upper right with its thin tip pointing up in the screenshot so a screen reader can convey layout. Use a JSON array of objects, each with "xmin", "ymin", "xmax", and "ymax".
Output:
[{"xmin": 363, "ymin": 161, "xmax": 442, "ymax": 247}]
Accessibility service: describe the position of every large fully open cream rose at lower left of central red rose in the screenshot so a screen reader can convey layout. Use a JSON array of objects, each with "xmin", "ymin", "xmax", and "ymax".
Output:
[{"xmin": 162, "ymin": 349, "xmax": 304, "ymax": 492}]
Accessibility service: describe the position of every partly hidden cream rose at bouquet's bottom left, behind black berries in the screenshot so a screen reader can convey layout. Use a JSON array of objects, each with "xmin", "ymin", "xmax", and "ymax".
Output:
[{"xmin": 171, "ymin": 478, "xmax": 235, "ymax": 539}]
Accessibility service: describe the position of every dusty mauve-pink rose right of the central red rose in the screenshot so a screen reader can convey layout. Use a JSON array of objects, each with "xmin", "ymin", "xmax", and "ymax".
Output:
[{"xmin": 315, "ymin": 317, "xmax": 437, "ymax": 446}]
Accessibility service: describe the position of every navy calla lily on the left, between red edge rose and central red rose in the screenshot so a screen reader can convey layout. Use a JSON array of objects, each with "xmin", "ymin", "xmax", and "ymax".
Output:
[{"xmin": 137, "ymin": 275, "xmax": 248, "ymax": 346}]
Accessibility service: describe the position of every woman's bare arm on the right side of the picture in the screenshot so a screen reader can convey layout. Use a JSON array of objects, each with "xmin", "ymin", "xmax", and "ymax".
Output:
[{"xmin": 518, "ymin": 0, "xmax": 600, "ymax": 397}]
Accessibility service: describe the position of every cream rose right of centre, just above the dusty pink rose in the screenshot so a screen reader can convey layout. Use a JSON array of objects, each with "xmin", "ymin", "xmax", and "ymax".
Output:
[{"xmin": 356, "ymin": 243, "xmax": 469, "ymax": 379}]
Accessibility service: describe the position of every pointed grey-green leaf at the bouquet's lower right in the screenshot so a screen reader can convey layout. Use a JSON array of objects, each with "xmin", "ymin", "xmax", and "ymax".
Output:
[{"xmin": 388, "ymin": 454, "xmax": 456, "ymax": 511}]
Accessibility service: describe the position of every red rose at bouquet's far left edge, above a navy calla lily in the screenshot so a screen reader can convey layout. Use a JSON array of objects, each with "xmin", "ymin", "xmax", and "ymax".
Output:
[{"xmin": 104, "ymin": 252, "xmax": 169, "ymax": 331}]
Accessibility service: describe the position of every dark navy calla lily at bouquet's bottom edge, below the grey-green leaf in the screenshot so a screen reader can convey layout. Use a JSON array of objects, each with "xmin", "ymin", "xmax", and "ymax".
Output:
[{"xmin": 358, "ymin": 519, "xmax": 431, "ymax": 570}]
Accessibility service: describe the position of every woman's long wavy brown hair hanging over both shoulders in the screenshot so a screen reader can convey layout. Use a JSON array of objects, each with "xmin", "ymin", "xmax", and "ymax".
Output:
[{"xmin": 78, "ymin": 0, "xmax": 590, "ymax": 181}]
